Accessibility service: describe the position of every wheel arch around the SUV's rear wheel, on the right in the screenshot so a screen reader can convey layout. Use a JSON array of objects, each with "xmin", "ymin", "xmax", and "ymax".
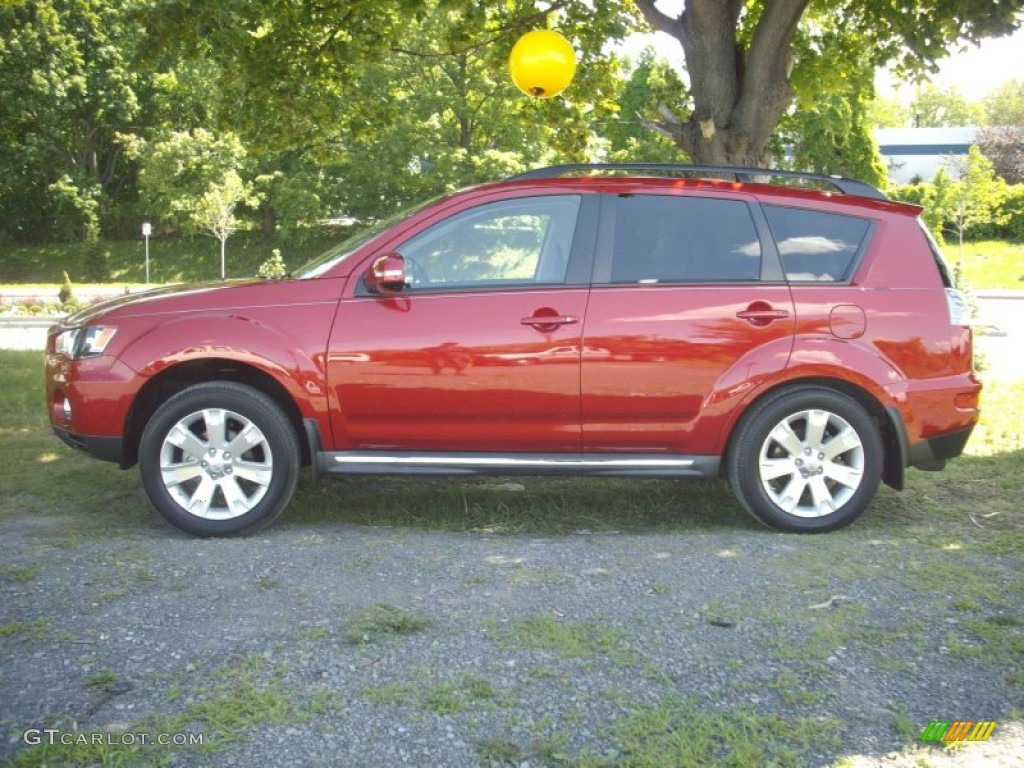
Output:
[{"xmin": 722, "ymin": 376, "xmax": 906, "ymax": 490}]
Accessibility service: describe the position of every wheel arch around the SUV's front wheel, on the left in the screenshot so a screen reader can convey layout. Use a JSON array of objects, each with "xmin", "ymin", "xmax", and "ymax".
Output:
[{"xmin": 121, "ymin": 357, "xmax": 311, "ymax": 469}]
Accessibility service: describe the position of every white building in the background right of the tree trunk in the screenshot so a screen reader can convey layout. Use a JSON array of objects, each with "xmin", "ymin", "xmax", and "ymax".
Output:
[{"xmin": 874, "ymin": 128, "xmax": 978, "ymax": 184}]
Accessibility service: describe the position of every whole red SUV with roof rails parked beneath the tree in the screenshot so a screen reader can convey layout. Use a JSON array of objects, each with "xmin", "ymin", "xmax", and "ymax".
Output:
[{"xmin": 46, "ymin": 164, "xmax": 981, "ymax": 537}]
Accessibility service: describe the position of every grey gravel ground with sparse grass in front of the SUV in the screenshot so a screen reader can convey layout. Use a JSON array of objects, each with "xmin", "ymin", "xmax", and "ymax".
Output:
[{"xmin": 0, "ymin": 483, "xmax": 1024, "ymax": 768}]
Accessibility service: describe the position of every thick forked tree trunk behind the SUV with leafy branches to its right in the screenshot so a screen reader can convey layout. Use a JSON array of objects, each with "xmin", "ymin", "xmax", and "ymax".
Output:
[{"xmin": 635, "ymin": 0, "xmax": 1022, "ymax": 165}]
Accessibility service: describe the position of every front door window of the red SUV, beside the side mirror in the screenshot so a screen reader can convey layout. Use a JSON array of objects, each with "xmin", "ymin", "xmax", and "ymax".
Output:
[{"xmin": 397, "ymin": 195, "xmax": 581, "ymax": 291}]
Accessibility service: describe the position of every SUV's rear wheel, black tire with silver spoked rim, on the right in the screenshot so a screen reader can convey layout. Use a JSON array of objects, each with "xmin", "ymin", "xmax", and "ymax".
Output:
[{"xmin": 727, "ymin": 387, "xmax": 884, "ymax": 534}]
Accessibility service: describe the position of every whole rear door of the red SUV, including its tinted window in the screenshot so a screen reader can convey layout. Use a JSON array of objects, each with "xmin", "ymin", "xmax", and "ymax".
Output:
[{"xmin": 582, "ymin": 195, "xmax": 794, "ymax": 454}]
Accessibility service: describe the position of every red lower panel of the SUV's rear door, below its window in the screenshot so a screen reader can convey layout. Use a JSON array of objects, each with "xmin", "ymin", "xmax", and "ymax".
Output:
[{"xmin": 582, "ymin": 285, "xmax": 794, "ymax": 454}]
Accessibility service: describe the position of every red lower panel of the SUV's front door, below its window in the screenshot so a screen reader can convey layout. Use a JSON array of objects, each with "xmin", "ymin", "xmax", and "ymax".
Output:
[{"xmin": 328, "ymin": 288, "xmax": 588, "ymax": 452}]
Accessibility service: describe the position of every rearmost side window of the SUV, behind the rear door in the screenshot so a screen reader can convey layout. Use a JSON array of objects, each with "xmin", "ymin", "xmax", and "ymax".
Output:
[{"xmin": 764, "ymin": 206, "xmax": 871, "ymax": 283}]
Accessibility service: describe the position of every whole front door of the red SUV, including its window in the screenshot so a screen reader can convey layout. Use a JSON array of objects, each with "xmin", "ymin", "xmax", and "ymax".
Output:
[{"xmin": 328, "ymin": 195, "xmax": 597, "ymax": 453}]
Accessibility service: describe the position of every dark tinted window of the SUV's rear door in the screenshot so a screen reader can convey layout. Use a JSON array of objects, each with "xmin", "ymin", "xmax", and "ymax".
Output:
[{"xmin": 611, "ymin": 195, "xmax": 761, "ymax": 283}]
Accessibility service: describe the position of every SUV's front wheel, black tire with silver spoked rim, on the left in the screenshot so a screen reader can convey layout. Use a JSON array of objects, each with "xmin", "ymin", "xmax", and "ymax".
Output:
[{"xmin": 138, "ymin": 382, "xmax": 300, "ymax": 537}]
